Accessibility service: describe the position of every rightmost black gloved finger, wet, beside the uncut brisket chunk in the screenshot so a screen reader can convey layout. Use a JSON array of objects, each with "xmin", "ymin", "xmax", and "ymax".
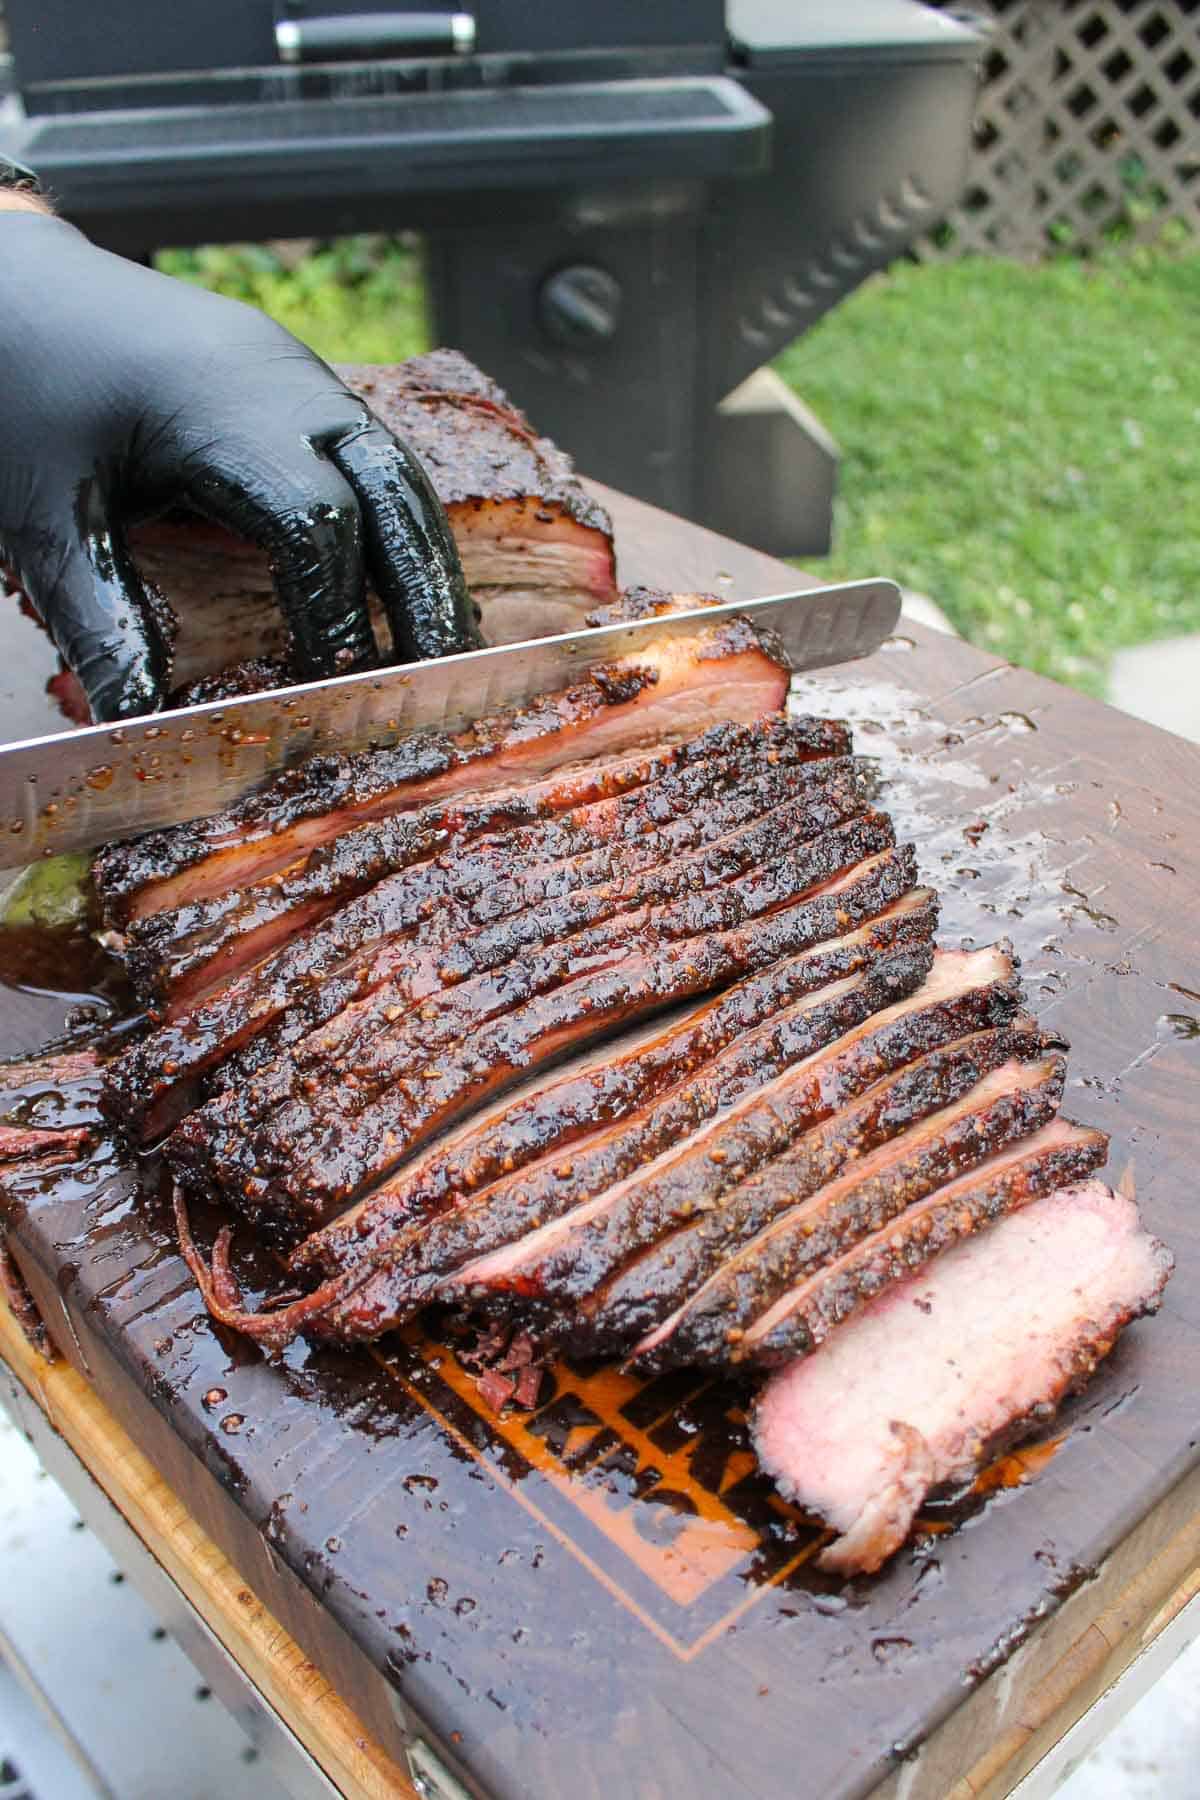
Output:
[{"xmin": 326, "ymin": 419, "xmax": 480, "ymax": 662}]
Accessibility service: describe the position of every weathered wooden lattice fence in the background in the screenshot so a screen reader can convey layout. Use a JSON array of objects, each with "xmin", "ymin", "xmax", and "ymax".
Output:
[{"xmin": 916, "ymin": 0, "xmax": 1200, "ymax": 259}]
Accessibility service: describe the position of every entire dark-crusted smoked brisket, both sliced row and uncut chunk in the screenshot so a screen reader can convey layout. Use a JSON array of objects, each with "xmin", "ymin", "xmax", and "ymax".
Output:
[{"xmin": 9, "ymin": 376, "xmax": 1171, "ymax": 1571}]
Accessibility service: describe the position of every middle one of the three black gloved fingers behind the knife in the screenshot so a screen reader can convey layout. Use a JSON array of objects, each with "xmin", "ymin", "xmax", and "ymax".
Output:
[{"xmin": 187, "ymin": 443, "xmax": 378, "ymax": 679}]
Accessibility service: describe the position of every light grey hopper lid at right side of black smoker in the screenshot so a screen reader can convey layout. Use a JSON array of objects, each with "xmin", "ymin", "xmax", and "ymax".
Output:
[{"xmin": 725, "ymin": 0, "xmax": 984, "ymax": 68}]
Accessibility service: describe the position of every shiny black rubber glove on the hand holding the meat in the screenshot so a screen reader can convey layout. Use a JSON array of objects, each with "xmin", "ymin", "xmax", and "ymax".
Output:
[{"xmin": 0, "ymin": 223, "xmax": 479, "ymax": 720}]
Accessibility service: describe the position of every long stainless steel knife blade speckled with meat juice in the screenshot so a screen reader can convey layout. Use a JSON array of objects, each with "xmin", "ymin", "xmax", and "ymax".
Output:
[{"xmin": 0, "ymin": 581, "xmax": 900, "ymax": 869}]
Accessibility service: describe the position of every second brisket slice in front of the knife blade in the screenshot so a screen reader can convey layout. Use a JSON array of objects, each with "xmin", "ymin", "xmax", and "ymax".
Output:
[{"xmin": 124, "ymin": 718, "xmax": 845, "ymax": 1010}]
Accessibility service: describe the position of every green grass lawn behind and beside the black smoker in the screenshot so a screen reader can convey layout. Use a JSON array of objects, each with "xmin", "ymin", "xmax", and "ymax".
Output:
[{"xmin": 160, "ymin": 239, "xmax": 1200, "ymax": 691}]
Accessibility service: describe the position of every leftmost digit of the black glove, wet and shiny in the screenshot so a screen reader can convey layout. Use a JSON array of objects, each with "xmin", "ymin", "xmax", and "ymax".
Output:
[{"xmin": 20, "ymin": 486, "xmax": 169, "ymax": 724}]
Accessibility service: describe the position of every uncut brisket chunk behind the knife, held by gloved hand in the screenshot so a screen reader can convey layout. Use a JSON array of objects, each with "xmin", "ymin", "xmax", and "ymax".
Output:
[{"xmin": 130, "ymin": 349, "xmax": 617, "ymax": 682}]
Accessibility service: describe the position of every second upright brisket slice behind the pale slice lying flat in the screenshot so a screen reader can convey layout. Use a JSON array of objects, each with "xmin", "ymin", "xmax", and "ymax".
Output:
[{"xmin": 631, "ymin": 1046, "xmax": 1067, "ymax": 1368}]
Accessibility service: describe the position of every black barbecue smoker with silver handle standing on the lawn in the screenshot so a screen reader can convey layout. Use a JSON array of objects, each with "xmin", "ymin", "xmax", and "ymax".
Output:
[{"xmin": 0, "ymin": 0, "xmax": 981, "ymax": 554}]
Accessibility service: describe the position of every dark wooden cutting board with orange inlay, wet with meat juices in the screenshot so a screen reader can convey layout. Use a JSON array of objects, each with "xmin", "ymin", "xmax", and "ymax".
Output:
[{"xmin": 0, "ymin": 495, "xmax": 1200, "ymax": 1800}]
